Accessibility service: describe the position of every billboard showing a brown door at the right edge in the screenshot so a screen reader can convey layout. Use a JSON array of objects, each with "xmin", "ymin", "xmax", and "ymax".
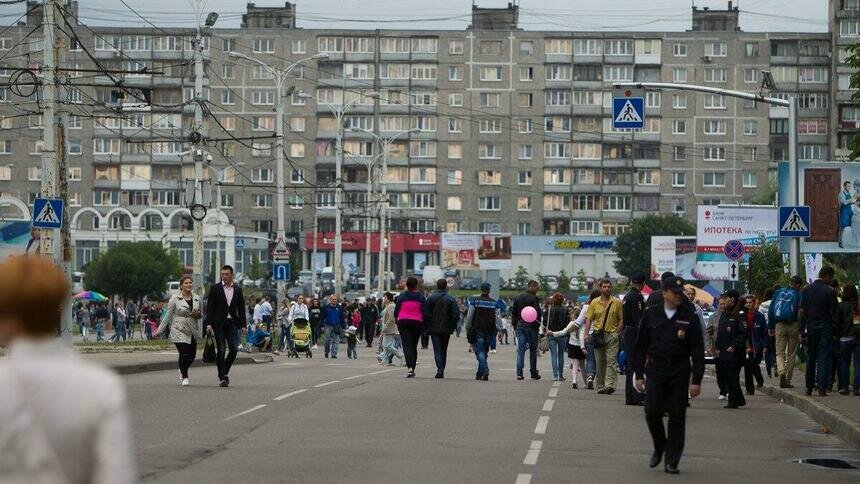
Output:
[{"xmin": 779, "ymin": 161, "xmax": 860, "ymax": 254}]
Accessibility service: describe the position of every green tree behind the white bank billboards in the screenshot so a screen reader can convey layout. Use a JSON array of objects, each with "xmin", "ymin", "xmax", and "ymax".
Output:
[{"xmin": 615, "ymin": 214, "xmax": 696, "ymax": 277}]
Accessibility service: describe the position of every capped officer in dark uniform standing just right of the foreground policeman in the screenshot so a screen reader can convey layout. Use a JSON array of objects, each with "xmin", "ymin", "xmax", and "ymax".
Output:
[{"xmin": 714, "ymin": 289, "xmax": 747, "ymax": 408}]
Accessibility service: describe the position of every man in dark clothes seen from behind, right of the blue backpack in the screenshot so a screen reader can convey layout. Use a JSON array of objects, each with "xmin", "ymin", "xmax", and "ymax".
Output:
[{"xmin": 799, "ymin": 266, "xmax": 839, "ymax": 397}]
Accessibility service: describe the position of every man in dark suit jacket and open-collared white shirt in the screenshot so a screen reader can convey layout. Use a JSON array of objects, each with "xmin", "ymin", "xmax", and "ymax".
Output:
[{"xmin": 206, "ymin": 265, "xmax": 246, "ymax": 387}]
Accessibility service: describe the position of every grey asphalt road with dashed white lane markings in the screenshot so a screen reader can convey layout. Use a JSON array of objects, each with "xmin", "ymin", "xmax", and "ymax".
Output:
[{"xmin": 126, "ymin": 339, "xmax": 860, "ymax": 484}]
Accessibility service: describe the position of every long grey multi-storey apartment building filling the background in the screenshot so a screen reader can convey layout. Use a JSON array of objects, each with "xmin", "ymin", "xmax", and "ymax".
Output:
[{"xmin": 0, "ymin": 0, "xmax": 844, "ymax": 273}]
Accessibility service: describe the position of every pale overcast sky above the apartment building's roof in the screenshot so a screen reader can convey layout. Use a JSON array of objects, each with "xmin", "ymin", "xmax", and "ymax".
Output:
[{"xmin": 0, "ymin": 0, "xmax": 828, "ymax": 32}]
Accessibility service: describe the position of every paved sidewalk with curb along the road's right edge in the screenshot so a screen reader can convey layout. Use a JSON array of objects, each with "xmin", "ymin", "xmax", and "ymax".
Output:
[{"xmin": 761, "ymin": 369, "xmax": 860, "ymax": 448}]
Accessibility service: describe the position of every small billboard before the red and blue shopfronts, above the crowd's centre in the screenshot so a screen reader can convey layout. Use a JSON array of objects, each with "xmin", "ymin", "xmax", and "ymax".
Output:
[{"xmin": 442, "ymin": 233, "xmax": 511, "ymax": 270}]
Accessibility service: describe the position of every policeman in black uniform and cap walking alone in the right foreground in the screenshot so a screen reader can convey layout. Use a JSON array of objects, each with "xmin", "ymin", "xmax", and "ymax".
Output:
[{"xmin": 633, "ymin": 277, "xmax": 705, "ymax": 474}]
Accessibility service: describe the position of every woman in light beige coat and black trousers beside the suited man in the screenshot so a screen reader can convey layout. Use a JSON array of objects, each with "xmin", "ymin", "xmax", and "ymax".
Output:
[{"xmin": 152, "ymin": 276, "xmax": 203, "ymax": 387}]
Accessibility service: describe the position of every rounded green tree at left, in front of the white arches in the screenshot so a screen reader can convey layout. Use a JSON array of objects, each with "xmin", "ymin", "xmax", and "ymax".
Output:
[{"xmin": 84, "ymin": 242, "xmax": 182, "ymax": 300}]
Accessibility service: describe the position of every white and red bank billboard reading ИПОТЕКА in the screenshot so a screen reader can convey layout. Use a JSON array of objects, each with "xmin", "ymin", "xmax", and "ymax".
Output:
[{"xmin": 693, "ymin": 205, "xmax": 779, "ymax": 281}]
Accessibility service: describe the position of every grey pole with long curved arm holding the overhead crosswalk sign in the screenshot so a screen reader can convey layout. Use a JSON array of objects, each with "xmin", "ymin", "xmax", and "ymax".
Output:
[{"xmin": 612, "ymin": 81, "xmax": 800, "ymax": 274}]
